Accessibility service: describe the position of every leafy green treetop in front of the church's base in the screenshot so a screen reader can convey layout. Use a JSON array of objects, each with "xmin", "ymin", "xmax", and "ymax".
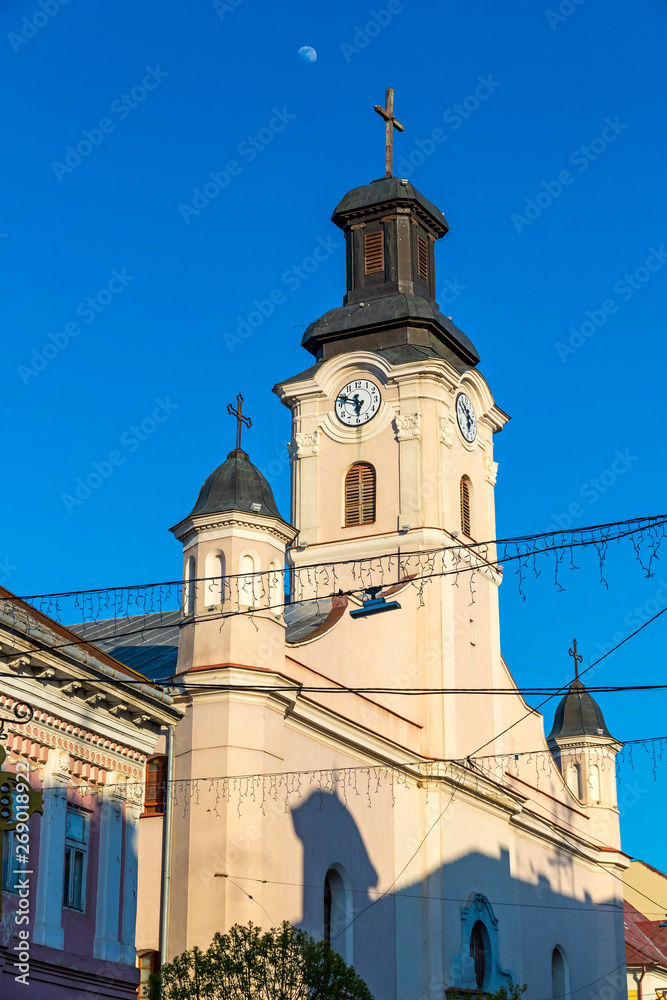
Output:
[{"xmin": 149, "ymin": 921, "xmax": 373, "ymax": 1000}]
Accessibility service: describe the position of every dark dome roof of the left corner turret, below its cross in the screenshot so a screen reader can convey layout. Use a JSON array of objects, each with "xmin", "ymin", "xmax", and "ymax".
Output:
[{"xmin": 190, "ymin": 448, "xmax": 290, "ymax": 521}]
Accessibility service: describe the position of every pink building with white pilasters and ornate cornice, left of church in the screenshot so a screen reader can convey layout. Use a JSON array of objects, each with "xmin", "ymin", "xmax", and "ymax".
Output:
[{"xmin": 0, "ymin": 588, "xmax": 181, "ymax": 1000}]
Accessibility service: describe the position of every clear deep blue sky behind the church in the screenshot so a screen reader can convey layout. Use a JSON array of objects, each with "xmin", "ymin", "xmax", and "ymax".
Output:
[{"xmin": 0, "ymin": 0, "xmax": 667, "ymax": 867}]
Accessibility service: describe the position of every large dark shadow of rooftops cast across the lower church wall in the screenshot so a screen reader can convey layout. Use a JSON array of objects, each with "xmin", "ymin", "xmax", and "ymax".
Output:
[{"xmin": 292, "ymin": 791, "xmax": 627, "ymax": 1000}]
